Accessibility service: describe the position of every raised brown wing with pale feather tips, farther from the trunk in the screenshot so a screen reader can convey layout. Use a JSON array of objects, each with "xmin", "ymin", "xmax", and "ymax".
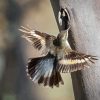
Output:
[{"xmin": 19, "ymin": 26, "xmax": 56, "ymax": 55}]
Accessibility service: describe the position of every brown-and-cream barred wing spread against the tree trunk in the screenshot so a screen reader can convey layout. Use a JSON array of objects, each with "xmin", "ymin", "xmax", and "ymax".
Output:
[{"xmin": 57, "ymin": 51, "xmax": 97, "ymax": 73}]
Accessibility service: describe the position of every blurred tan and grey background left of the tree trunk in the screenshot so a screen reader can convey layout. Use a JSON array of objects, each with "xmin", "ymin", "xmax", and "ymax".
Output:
[{"xmin": 0, "ymin": 0, "xmax": 74, "ymax": 100}]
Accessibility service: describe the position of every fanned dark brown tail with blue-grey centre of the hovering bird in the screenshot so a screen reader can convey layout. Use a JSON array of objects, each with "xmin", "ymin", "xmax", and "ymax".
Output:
[{"xmin": 27, "ymin": 54, "xmax": 63, "ymax": 87}]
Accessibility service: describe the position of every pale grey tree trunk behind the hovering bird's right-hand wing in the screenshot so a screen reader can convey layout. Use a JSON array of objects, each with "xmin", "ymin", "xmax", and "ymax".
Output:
[{"xmin": 50, "ymin": 0, "xmax": 100, "ymax": 100}]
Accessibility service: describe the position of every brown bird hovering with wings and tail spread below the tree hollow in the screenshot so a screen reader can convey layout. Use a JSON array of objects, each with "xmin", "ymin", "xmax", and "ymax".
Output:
[{"xmin": 19, "ymin": 25, "xmax": 98, "ymax": 88}]
